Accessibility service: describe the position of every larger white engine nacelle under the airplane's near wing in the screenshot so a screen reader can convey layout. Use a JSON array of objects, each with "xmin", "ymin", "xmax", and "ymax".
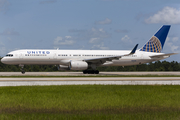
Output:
[{"xmin": 69, "ymin": 61, "xmax": 88, "ymax": 70}]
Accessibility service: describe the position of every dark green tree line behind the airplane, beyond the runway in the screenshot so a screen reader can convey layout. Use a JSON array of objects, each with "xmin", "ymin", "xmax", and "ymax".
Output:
[{"xmin": 0, "ymin": 58, "xmax": 180, "ymax": 72}]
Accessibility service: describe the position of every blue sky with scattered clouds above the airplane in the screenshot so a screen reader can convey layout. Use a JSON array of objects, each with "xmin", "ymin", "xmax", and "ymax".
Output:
[{"xmin": 0, "ymin": 0, "xmax": 180, "ymax": 62}]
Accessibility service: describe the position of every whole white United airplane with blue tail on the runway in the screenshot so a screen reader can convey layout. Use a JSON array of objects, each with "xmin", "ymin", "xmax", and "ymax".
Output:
[{"xmin": 1, "ymin": 25, "xmax": 178, "ymax": 74}]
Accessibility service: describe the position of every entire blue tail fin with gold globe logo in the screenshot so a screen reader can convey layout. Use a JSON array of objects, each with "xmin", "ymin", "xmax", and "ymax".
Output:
[{"xmin": 140, "ymin": 25, "xmax": 171, "ymax": 53}]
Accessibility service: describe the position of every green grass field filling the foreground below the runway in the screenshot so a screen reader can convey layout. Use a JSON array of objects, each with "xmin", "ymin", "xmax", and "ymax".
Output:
[{"xmin": 0, "ymin": 85, "xmax": 180, "ymax": 120}]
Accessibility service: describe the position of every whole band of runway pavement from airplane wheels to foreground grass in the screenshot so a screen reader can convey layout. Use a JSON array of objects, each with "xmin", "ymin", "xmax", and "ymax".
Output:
[{"xmin": 0, "ymin": 72, "xmax": 180, "ymax": 86}]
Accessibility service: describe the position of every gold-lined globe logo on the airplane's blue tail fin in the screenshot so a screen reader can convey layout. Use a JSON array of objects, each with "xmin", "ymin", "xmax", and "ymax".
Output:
[{"xmin": 140, "ymin": 36, "xmax": 162, "ymax": 53}]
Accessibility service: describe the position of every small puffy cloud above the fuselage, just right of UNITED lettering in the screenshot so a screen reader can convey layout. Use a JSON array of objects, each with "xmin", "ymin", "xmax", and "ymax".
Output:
[{"xmin": 54, "ymin": 36, "xmax": 75, "ymax": 45}]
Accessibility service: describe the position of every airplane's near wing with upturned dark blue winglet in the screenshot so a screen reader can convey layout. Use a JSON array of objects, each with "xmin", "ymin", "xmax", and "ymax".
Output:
[{"xmin": 84, "ymin": 44, "xmax": 138, "ymax": 64}]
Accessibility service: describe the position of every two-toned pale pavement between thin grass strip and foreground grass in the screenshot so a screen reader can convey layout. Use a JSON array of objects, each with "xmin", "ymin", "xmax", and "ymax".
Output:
[{"xmin": 0, "ymin": 77, "xmax": 180, "ymax": 86}]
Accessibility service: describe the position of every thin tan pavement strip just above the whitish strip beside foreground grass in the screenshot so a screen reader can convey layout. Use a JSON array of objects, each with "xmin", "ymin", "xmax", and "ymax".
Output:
[{"xmin": 0, "ymin": 77, "xmax": 180, "ymax": 82}]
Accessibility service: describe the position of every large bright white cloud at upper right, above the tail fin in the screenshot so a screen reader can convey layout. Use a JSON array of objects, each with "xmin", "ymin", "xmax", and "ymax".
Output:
[{"xmin": 145, "ymin": 7, "xmax": 180, "ymax": 24}]
